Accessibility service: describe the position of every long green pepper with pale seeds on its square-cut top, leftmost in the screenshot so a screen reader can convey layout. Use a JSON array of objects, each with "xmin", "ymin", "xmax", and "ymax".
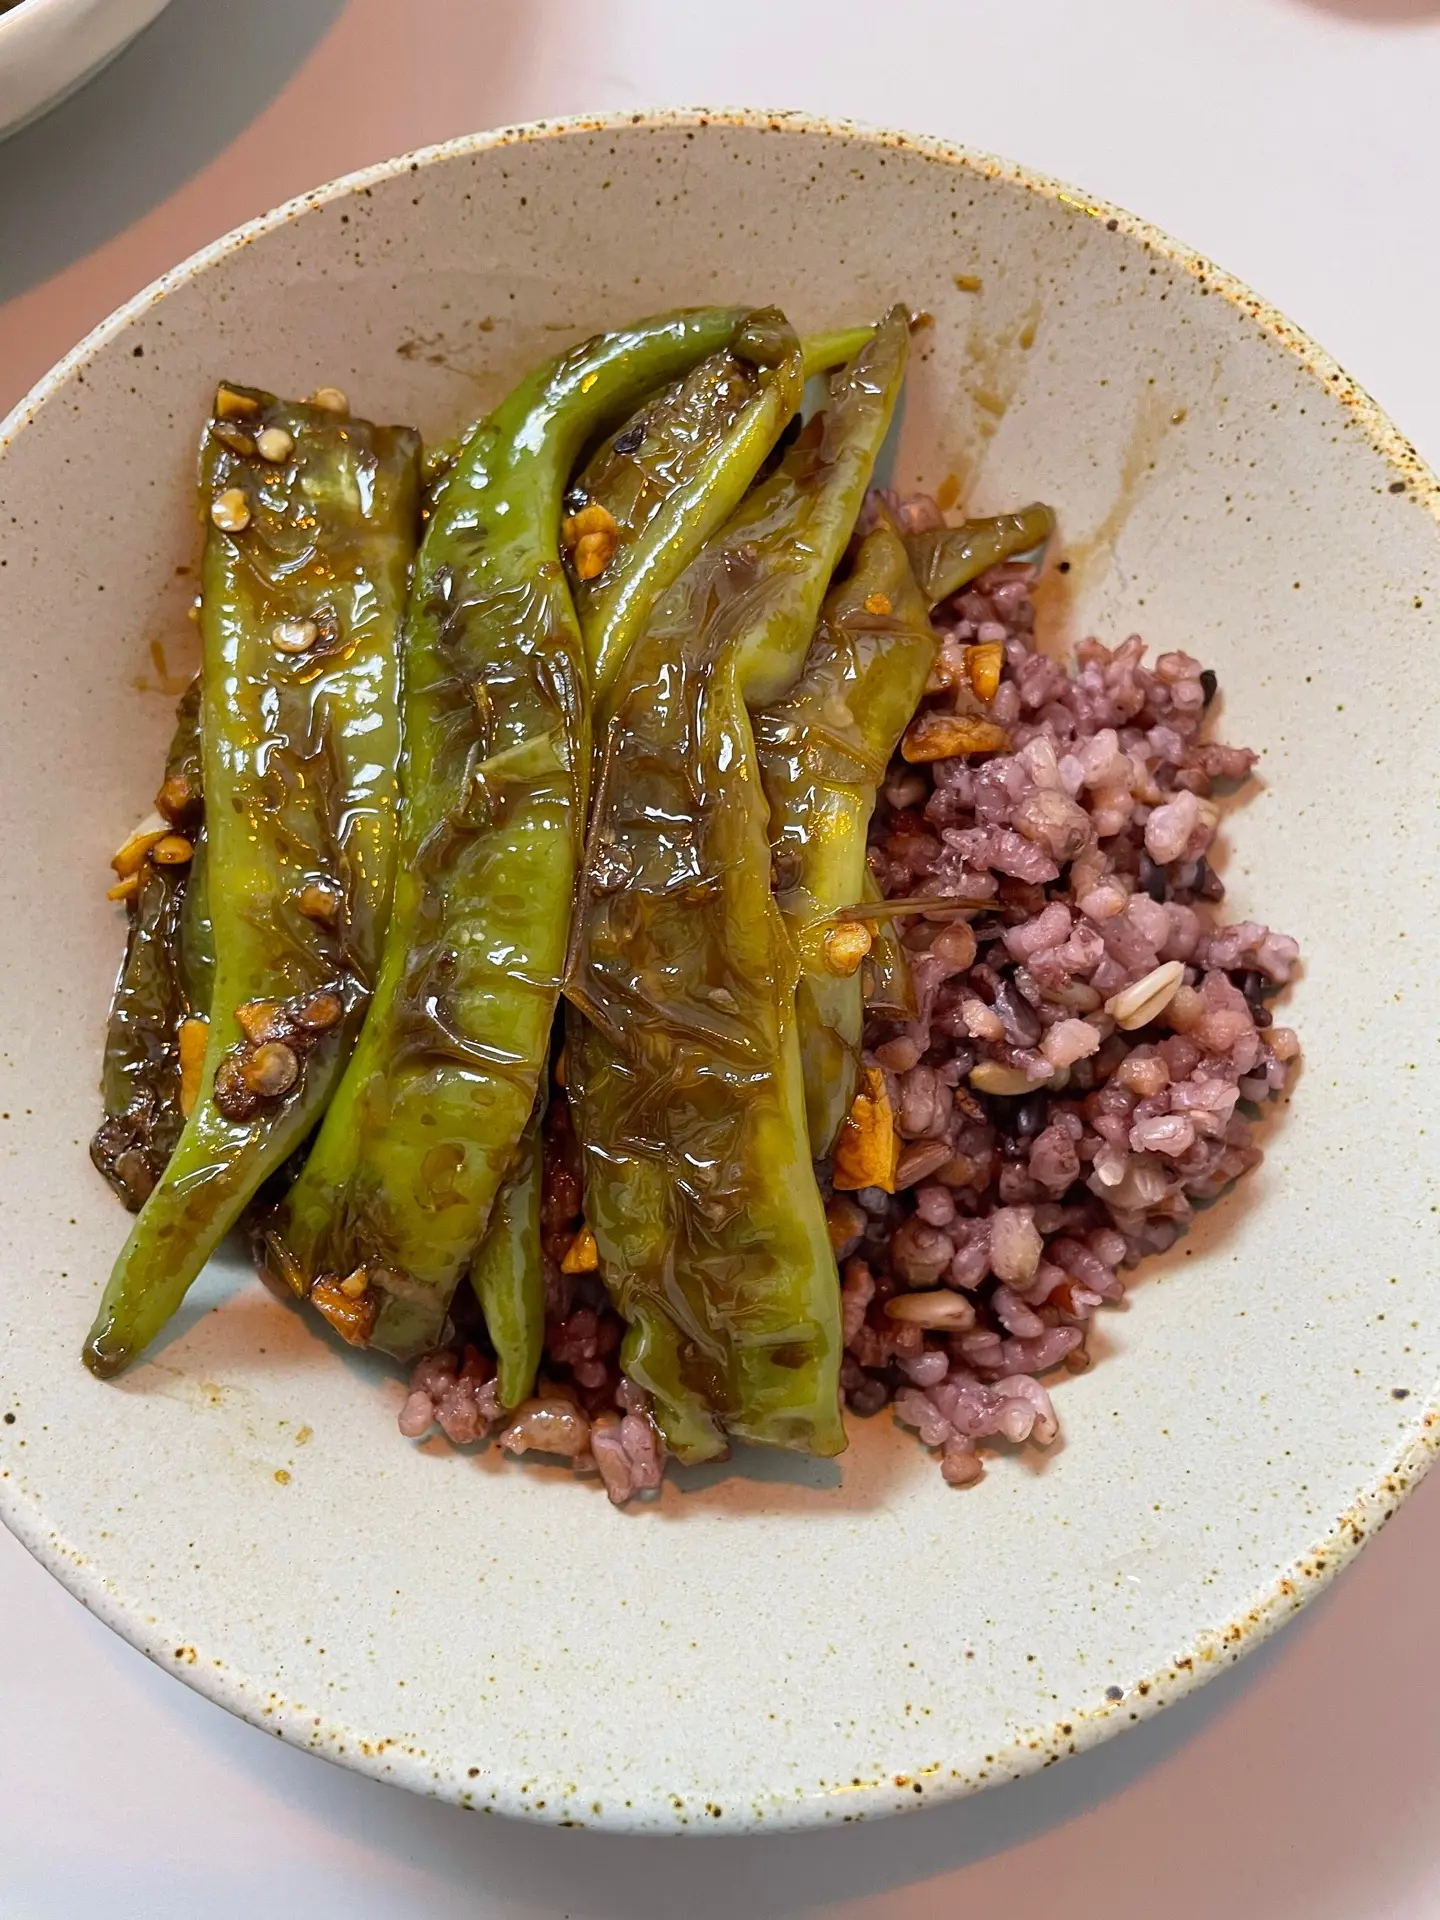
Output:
[{"xmin": 84, "ymin": 388, "xmax": 420, "ymax": 1375}]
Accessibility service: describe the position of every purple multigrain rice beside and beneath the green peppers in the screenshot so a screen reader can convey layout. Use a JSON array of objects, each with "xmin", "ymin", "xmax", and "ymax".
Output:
[{"xmin": 389, "ymin": 495, "xmax": 1300, "ymax": 1505}]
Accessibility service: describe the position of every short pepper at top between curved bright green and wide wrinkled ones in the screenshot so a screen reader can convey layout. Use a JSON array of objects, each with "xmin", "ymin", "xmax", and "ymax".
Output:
[{"xmin": 566, "ymin": 309, "xmax": 856, "ymax": 707}]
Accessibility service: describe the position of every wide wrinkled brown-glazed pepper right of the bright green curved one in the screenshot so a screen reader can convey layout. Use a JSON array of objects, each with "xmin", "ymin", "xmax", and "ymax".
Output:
[{"xmin": 566, "ymin": 315, "xmax": 906, "ymax": 1461}]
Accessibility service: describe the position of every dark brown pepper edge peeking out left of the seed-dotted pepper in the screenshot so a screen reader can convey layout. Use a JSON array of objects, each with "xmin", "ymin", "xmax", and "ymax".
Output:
[{"xmin": 90, "ymin": 678, "xmax": 207, "ymax": 1212}]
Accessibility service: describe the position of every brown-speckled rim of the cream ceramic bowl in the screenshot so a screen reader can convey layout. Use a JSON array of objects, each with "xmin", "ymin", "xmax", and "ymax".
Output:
[{"xmin": 0, "ymin": 108, "xmax": 1440, "ymax": 1832}]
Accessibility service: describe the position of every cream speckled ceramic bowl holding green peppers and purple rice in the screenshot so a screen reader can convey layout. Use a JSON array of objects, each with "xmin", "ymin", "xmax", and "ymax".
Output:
[{"xmin": 0, "ymin": 113, "xmax": 1440, "ymax": 1832}]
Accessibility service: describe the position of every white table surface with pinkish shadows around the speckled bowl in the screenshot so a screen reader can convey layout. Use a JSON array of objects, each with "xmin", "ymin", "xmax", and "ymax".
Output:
[{"xmin": 0, "ymin": 0, "xmax": 1440, "ymax": 1920}]
